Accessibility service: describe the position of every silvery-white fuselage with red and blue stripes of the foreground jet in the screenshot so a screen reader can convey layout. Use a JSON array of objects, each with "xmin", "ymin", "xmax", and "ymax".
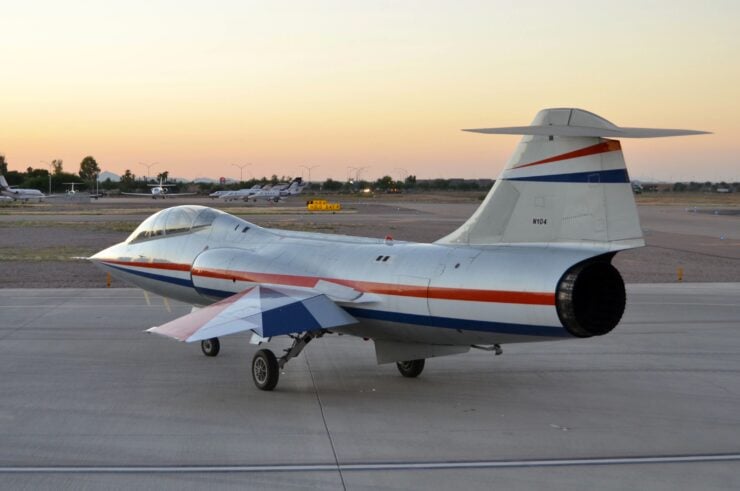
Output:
[{"xmin": 92, "ymin": 208, "xmax": 608, "ymax": 345}]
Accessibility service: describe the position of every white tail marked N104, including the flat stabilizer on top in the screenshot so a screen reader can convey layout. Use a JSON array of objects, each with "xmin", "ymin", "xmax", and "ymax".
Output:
[{"xmin": 437, "ymin": 109, "xmax": 703, "ymax": 250}]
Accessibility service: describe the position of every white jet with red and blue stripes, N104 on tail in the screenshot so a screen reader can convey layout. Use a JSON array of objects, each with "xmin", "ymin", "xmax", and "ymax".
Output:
[{"xmin": 91, "ymin": 109, "xmax": 702, "ymax": 390}]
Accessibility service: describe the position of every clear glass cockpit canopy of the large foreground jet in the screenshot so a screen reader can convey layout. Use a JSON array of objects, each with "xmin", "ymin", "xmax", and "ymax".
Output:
[{"xmin": 126, "ymin": 205, "xmax": 224, "ymax": 243}]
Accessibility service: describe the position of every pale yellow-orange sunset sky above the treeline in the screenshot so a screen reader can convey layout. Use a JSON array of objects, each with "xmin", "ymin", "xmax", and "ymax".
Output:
[{"xmin": 0, "ymin": 0, "xmax": 740, "ymax": 181}]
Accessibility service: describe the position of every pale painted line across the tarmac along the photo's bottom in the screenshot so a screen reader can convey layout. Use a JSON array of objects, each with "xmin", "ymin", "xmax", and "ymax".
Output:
[{"xmin": 0, "ymin": 453, "xmax": 740, "ymax": 474}]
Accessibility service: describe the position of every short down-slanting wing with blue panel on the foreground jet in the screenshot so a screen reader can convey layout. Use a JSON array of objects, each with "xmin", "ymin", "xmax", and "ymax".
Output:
[{"xmin": 147, "ymin": 286, "xmax": 357, "ymax": 343}]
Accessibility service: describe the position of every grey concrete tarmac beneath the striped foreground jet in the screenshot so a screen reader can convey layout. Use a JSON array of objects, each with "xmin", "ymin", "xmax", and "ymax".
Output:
[{"xmin": 0, "ymin": 283, "xmax": 740, "ymax": 490}]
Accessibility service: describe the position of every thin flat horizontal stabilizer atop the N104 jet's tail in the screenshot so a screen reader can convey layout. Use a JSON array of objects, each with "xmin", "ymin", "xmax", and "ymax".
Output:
[{"xmin": 463, "ymin": 125, "xmax": 709, "ymax": 138}]
